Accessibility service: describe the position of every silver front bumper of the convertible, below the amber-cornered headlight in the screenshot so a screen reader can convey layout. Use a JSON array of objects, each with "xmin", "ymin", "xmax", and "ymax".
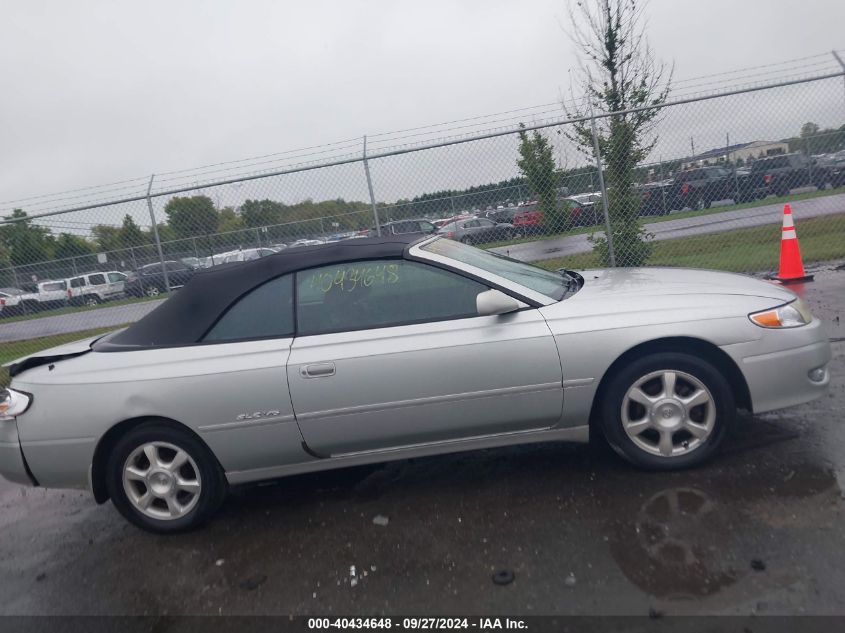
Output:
[{"xmin": 723, "ymin": 319, "xmax": 831, "ymax": 413}]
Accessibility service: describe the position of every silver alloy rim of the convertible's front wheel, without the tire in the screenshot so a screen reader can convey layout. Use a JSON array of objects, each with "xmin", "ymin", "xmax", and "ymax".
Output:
[{"xmin": 622, "ymin": 370, "xmax": 716, "ymax": 457}]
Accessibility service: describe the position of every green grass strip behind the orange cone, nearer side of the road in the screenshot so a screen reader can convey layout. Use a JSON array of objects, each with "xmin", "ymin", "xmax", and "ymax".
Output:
[{"xmin": 537, "ymin": 215, "xmax": 845, "ymax": 272}]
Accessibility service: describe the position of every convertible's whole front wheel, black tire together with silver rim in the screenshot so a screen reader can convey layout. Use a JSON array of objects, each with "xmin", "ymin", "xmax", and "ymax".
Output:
[{"xmin": 598, "ymin": 352, "xmax": 736, "ymax": 470}]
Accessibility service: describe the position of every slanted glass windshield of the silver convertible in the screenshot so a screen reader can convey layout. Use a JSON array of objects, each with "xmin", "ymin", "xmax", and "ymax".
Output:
[{"xmin": 422, "ymin": 239, "xmax": 569, "ymax": 301}]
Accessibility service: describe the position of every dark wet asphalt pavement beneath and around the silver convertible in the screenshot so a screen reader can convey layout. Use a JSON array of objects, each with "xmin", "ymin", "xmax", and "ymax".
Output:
[{"xmin": 0, "ymin": 267, "xmax": 845, "ymax": 615}]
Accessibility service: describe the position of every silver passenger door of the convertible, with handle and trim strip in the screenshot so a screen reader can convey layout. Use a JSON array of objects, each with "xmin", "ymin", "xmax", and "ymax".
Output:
[{"xmin": 288, "ymin": 309, "xmax": 563, "ymax": 455}]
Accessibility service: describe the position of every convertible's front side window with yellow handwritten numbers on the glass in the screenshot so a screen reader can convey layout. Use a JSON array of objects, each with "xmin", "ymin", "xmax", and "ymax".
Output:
[{"xmin": 296, "ymin": 260, "xmax": 488, "ymax": 336}]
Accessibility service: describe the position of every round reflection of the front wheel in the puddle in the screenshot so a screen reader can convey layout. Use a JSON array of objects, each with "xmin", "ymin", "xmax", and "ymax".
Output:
[{"xmin": 611, "ymin": 488, "xmax": 737, "ymax": 599}]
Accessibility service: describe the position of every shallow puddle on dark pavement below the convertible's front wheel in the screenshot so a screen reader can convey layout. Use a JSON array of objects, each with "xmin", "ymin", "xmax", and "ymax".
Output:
[{"xmin": 606, "ymin": 463, "xmax": 845, "ymax": 601}]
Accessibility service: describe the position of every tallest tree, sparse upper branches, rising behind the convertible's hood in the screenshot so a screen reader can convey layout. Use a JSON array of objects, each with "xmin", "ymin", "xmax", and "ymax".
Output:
[{"xmin": 565, "ymin": 0, "xmax": 672, "ymax": 266}]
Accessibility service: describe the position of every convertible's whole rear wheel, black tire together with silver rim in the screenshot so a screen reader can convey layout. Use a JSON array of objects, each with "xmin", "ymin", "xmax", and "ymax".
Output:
[{"xmin": 106, "ymin": 422, "xmax": 228, "ymax": 534}]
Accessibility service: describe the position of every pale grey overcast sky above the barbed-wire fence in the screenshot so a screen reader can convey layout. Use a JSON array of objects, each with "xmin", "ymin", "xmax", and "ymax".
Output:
[{"xmin": 0, "ymin": 0, "xmax": 845, "ymax": 215}]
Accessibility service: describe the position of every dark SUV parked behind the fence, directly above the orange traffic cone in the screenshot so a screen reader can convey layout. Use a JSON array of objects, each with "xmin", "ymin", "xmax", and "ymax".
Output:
[{"xmin": 745, "ymin": 153, "xmax": 836, "ymax": 199}]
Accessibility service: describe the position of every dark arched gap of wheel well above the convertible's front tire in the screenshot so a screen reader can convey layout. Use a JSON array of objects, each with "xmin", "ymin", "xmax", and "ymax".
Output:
[{"xmin": 590, "ymin": 336, "xmax": 752, "ymax": 427}]
